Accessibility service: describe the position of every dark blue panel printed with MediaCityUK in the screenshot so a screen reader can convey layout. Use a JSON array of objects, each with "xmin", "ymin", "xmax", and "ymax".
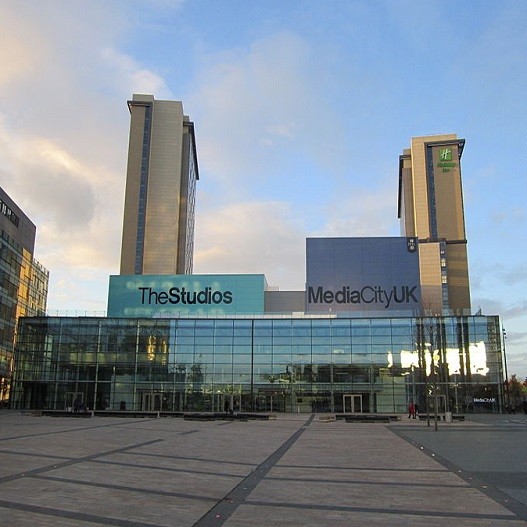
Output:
[{"xmin": 306, "ymin": 237, "xmax": 421, "ymax": 313}]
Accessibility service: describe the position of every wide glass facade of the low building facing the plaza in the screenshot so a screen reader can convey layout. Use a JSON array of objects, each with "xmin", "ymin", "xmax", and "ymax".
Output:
[{"xmin": 12, "ymin": 316, "xmax": 503, "ymax": 413}]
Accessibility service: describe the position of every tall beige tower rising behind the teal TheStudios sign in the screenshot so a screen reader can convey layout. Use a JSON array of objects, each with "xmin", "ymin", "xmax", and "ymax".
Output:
[{"xmin": 120, "ymin": 95, "xmax": 199, "ymax": 275}]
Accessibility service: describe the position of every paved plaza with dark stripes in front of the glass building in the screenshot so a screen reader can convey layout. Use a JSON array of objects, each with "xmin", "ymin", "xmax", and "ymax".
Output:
[{"xmin": 0, "ymin": 410, "xmax": 527, "ymax": 527}]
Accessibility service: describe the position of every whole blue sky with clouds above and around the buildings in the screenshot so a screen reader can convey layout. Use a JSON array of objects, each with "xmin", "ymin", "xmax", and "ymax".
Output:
[{"xmin": 0, "ymin": 0, "xmax": 527, "ymax": 378}]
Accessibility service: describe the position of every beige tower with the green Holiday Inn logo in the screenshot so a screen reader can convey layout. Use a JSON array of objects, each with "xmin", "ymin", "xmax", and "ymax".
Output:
[{"xmin": 398, "ymin": 134, "xmax": 470, "ymax": 314}]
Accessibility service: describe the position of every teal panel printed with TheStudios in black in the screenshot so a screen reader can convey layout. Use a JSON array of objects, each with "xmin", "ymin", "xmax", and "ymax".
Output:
[{"xmin": 108, "ymin": 274, "xmax": 266, "ymax": 318}]
